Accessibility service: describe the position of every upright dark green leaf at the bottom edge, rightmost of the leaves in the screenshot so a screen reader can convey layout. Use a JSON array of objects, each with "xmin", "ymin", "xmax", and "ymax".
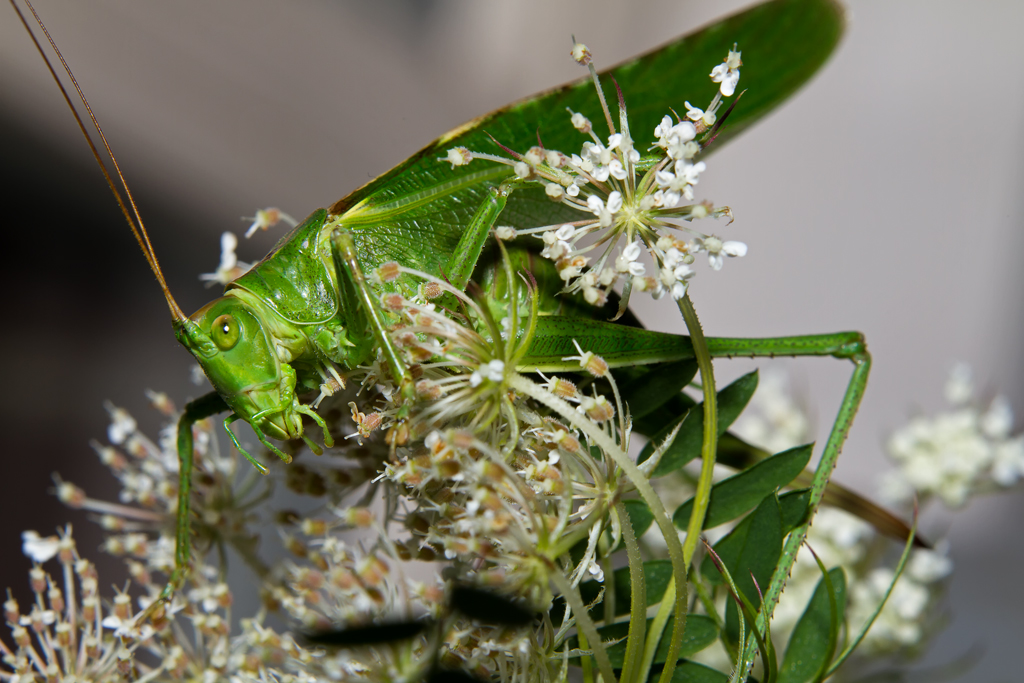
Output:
[{"xmin": 778, "ymin": 567, "xmax": 846, "ymax": 683}]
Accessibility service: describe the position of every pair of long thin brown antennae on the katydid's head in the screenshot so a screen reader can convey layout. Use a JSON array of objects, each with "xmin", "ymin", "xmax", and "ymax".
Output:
[{"xmin": 9, "ymin": 0, "xmax": 186, "ymax": 322}]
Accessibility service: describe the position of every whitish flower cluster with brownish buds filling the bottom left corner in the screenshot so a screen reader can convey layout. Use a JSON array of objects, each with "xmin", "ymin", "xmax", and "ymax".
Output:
[{"xmin": 0, "ymin": 526, "xmax": 319, "ymax": 683}]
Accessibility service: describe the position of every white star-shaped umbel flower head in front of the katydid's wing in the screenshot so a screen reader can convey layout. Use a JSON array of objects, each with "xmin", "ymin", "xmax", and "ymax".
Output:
[{"xmin": 445, "ymin": 43, "xmax": 746, "ymax": 310}]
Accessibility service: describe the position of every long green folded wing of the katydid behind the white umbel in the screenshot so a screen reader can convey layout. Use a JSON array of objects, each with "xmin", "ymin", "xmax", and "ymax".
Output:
[{"xmin": 330, "ymin": 0, "xmax": 844, "ymax": 274}]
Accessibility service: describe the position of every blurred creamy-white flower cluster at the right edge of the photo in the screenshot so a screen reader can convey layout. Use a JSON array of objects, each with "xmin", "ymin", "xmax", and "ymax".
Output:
[{"xmin": 882, "ymin": 366, "xmax": 1024, "ymax": 507}]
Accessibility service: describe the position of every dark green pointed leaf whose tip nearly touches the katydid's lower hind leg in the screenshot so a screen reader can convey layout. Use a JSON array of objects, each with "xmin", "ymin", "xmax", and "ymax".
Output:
[{"xmin": 672, "ymin": 443, "xmax": 814, "ymax": 528}]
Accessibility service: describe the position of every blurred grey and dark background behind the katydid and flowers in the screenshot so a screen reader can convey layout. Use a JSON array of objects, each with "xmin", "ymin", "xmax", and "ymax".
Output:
[{"xmin": 0, "ymin": 0, "xmax": 1024, "ymax": 681}]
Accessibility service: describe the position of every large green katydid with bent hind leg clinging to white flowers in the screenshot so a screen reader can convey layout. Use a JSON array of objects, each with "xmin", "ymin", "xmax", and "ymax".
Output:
[{"xmin": 14, "ymin": 0, "xmax": 888, "ymax": 663}]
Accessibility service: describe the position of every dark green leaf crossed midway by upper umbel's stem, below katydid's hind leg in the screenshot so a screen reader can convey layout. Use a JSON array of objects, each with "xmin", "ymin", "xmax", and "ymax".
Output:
[{"xmin": 637, "ymin": 370, "xmax": 758, "ymax": 477}]
